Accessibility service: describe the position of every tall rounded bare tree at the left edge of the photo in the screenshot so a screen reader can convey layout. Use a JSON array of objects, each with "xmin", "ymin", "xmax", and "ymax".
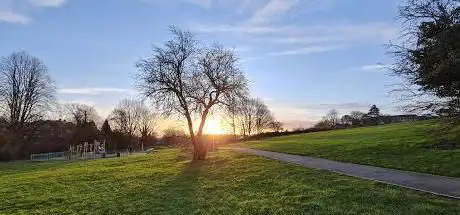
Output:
[{"xmin": 0, "ymin": 51, "xmax": 55, "ymax": 129}]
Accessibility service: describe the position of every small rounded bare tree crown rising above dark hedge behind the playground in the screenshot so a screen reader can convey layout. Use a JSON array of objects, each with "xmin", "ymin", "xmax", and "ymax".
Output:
[{"xmin": 63, "ymin": 103, "xmax": 101, "ymax": 127}]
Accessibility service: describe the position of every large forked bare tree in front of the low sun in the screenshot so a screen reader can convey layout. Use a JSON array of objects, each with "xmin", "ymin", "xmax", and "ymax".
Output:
[{"xmin": 137, "ymin": 28, "xmax": 247, "ymax": 160}]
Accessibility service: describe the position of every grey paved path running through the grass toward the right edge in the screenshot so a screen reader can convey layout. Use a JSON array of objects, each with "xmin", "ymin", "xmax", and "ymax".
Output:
[{"xmin": 232, "ymin": 148, "xmax": 460, "ymax": 199}]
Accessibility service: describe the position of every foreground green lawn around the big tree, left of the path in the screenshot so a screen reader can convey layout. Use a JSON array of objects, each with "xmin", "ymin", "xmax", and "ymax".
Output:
[{"xmin": 0, "ymin": 149, "xmax": 460, "ymax": 215}]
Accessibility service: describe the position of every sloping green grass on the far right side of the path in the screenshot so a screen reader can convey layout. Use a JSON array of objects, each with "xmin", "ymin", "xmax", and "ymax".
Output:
[{"xmin": 242, "ymin": 121, "xmax": 460, "ymax": 177}]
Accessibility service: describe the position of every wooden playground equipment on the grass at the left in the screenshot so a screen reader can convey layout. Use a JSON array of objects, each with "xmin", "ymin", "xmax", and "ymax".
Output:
[{"xmin": 67, "ymin": 140, "xmax": 106, "ymax": 160}]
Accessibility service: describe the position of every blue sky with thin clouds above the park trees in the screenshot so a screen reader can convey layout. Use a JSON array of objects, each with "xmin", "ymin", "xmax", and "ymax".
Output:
[{"xmin": 0, "ymin": 0, "xmax": 401, "ymax": 128}]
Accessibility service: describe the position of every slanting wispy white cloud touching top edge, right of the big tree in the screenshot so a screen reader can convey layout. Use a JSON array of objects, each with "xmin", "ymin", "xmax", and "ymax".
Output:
[{"xmin": 248, "ymin": 0, "xmax": 299, "ymax": 25}]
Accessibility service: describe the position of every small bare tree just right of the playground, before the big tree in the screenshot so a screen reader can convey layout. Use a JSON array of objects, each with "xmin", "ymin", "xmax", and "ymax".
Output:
[{"xmin": 110, "ymin": 99, "xmax": 143, "ymax": 147}]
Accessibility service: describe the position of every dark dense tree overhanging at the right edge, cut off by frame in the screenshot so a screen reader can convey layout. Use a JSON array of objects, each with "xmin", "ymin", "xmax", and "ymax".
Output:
[{"xmin": 390, "ymin": 0, "xmax": 460, "ymax": 116}]
